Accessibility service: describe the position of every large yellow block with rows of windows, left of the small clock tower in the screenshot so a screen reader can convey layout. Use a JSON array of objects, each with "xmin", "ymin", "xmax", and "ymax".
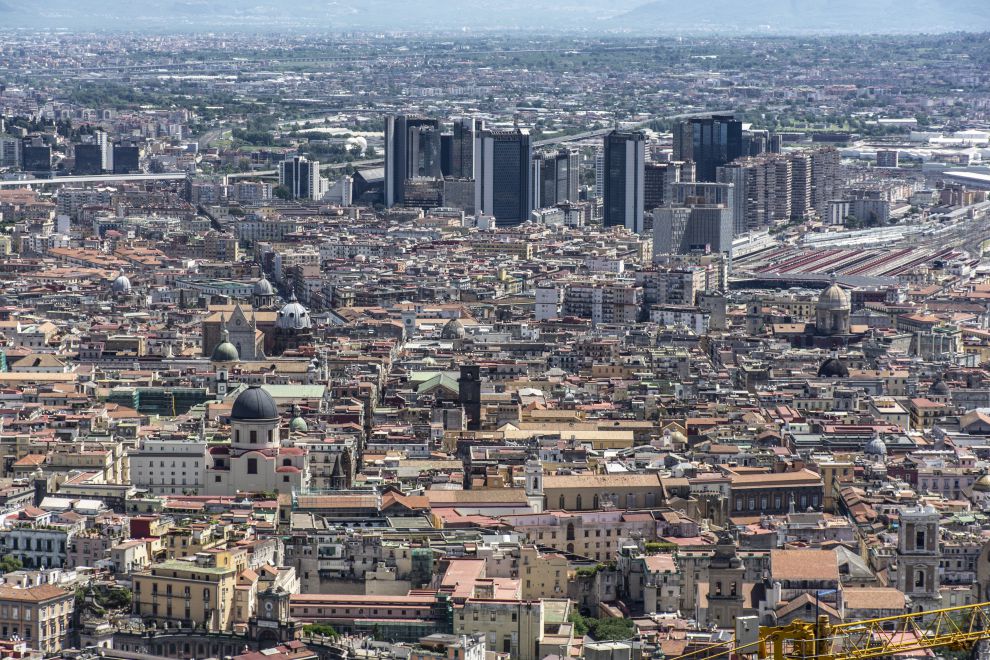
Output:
[{"xmin": 133, "ymin": 551, "xmax": 242, "ymax": 631}]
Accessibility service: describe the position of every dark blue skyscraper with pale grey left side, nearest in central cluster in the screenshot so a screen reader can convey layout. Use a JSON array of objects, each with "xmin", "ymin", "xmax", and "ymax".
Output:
[{"xmin": 474, "ymin": 128, "xmax": 533, "ymax": 226}]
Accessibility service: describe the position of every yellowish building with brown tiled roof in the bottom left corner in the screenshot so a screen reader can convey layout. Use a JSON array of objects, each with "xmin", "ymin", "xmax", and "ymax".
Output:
[{"xmin": 0, "ymin": 584, "xmax": 75, "ymax": 655}]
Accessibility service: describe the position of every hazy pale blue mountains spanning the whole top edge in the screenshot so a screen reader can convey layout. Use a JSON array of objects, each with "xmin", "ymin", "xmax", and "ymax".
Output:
[{"xmin": 0, "ymin": 0, "xmax": 990, "ymax": 34}]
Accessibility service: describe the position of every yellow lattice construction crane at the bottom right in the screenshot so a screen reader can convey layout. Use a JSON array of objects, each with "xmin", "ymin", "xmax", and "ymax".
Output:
[{"xmin": 672, "ymin": 603, "xmax": 990, "ymax": 660}]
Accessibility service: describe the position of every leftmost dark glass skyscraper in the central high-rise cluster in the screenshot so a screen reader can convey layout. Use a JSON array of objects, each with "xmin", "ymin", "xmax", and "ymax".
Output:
[{"xmin": 385, "ymin": 115, "xmax": 443, "ymax": 207}]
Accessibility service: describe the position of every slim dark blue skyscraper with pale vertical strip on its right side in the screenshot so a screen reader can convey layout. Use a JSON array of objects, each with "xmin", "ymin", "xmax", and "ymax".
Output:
[{"xmin": 603, "ymin": 130, "xmax": 646, "ymax": 233}]
